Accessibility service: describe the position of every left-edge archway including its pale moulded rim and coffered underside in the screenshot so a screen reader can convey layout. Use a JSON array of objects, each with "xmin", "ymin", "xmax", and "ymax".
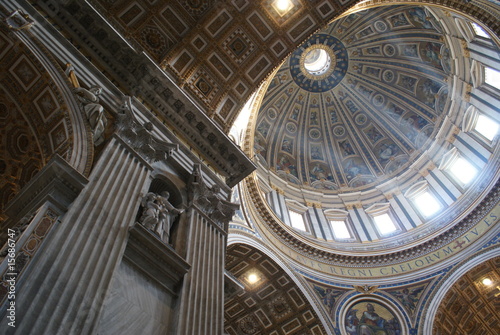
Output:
[{"xmin": 0, "ymin": 26, "xmax": 94, "ymax": 215}]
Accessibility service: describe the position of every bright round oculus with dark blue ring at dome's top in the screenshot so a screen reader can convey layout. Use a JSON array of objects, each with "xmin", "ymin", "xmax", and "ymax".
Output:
[{"xmin": 290, "ymin": 34, "xmax": 348, "ymax": 92}]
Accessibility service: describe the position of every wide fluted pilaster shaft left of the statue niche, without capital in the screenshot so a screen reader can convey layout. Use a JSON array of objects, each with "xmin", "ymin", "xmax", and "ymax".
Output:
[{"xmin": 0, "ymin": 137, "xmax": 151, "ymax": 335}]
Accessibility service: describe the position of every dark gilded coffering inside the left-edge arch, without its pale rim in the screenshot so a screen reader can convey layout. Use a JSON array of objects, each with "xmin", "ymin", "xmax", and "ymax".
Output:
[{"xmin": 0, "ymin": 26, "xmax": 73, "ymax": 215}]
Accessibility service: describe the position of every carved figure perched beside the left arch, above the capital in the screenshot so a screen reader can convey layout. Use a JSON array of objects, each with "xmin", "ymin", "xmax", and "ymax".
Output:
[{"xmin": 73, "ymin": 86, "xmax": 107, "ymax": 145}]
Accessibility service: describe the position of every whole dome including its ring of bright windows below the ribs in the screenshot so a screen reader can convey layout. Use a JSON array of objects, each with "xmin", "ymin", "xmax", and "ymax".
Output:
[{"xmin": 251, "ymin": 5, "xmax": 499, "ymax": 253}]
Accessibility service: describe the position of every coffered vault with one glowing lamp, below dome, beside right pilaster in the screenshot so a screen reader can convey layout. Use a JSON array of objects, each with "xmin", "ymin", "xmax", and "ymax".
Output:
[{"xmin": 224, "ymin": 244, "xmax": 327, "ymax": 335}]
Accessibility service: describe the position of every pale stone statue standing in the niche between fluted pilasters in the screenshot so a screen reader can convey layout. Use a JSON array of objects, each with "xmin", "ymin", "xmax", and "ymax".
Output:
[{"xmin": 139, "ymin": 191, "xmax": 184, "ymax": 243}]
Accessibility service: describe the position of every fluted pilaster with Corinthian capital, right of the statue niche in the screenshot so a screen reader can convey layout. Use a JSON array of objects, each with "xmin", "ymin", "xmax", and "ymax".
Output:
[{"xmin": 175, "ymin": 167, "xmax": 238, "ymax": 335}]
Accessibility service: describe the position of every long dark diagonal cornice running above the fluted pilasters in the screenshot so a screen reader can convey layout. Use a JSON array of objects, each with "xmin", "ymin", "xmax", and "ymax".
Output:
[{"xmin": 31, "ymin": 3, "xmax": 255, "ymax": 187}]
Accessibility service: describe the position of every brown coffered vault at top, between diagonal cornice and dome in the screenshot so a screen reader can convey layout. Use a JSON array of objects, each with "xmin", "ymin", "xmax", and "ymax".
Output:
[{"xmin": 87, "ymin": 0, "xmax": 498, "ymax": 132}]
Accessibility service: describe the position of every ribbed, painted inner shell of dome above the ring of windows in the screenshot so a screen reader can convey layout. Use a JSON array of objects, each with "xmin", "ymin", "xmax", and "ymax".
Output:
[{"xmin": 254, "ymin": 6, "xmax": 451, "ymax": 194}]
